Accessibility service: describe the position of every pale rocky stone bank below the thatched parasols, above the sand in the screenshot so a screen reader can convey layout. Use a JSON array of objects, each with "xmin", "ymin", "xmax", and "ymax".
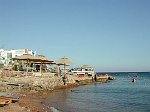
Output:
[{"xmin": 0, "ymin": 73, "xmax": 112, "ymax": 91}]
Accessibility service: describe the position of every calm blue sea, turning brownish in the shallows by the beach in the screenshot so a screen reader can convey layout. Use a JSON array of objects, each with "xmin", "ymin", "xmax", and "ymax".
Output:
[{"xmin": 45, "ymin": 72, "xmax": 150, "ymax": 112}]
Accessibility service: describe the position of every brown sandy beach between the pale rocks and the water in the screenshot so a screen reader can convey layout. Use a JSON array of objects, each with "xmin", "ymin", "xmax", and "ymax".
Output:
[{"xmin": 0, "ymin": 84, "xmax": 79, "ymax": 112}]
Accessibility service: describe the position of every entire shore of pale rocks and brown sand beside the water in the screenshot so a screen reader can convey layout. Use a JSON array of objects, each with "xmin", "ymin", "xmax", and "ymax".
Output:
[{"xmin": 0, "ymin": 73, "xmax": 112, "ymax": 112}]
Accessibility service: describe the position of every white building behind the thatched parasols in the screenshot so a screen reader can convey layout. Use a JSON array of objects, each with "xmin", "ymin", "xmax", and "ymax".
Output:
[{"xmin": 0, "ymin": 49, "xmax": 36, "ymax": 66}]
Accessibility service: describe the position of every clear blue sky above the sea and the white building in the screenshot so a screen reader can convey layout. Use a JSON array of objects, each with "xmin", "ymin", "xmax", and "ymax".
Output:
[{"xmin": 0, "ymin": 0, "xmax": 150, "ymax": 72}]
